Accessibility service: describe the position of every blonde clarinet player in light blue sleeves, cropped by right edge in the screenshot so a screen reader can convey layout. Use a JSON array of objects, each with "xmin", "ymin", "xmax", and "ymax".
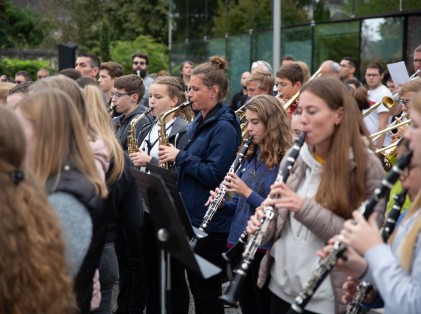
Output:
[{"xmin": 324, "ymin": 92, "xmax": 421, "ymax": 314}]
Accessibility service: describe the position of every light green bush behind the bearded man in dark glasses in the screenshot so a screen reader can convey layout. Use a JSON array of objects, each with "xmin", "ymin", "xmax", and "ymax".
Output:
[{"xmin": 111, "ymin": 35, "xmax": 169, "ymax": 73}]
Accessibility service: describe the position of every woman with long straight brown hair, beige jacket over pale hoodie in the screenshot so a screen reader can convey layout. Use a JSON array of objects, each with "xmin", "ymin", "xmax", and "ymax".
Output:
[{"xmin": 247, "ymin": 77, "xmax": 384, "ymax": 314}]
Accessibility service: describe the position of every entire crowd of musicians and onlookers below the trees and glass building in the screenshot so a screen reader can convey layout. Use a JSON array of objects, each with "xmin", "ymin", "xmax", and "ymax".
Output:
[{"xmin": 0, "ymin": 45, "xmax": 421, "ymax": 314}]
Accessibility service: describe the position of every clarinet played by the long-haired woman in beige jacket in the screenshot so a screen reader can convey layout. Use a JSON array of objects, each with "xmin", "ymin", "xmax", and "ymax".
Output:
[{"xmin": 220, "ymin": 132, "xmax": 306, "ymax": 307}]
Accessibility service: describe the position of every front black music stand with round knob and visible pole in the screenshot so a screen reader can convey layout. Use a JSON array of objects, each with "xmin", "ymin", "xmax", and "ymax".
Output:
[{"xmin": 132, "ymin": 168, "xmax": 221, "ymax": 314}]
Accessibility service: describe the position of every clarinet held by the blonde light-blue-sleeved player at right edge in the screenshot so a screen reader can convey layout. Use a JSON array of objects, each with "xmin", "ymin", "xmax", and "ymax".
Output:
[{"xmin": 288, "ymin": 151, "xmax": 412, "ymax": 314}]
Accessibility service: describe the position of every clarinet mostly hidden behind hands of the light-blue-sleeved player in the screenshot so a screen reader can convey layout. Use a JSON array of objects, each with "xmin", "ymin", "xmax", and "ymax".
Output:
[{"xmin": 346, "ymin": 189, "xmax": 408, "ymax": 314}]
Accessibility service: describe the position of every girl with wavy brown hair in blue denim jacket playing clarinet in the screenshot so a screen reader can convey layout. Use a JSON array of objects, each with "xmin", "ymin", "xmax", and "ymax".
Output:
[{"xmin": 206, "ymin": 95, "xmax": 292, "ymax": 314}]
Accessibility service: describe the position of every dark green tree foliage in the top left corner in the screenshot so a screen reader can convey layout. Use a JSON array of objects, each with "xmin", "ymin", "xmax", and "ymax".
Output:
[{"xmin": 0, "ymin": 0, "xmax": 46, "ymax": 48}]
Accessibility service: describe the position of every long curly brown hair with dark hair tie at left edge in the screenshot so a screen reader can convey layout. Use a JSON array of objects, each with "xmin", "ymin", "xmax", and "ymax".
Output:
[{"xmin": 0, "ymin": 108, "xmax": 77, "ymax": 314}]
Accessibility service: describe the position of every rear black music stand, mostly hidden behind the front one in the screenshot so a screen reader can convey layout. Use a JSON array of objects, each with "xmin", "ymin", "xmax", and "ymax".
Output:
[{"xmin": 146, "ymin": 163, "xmax": 208, "ymax": 239}]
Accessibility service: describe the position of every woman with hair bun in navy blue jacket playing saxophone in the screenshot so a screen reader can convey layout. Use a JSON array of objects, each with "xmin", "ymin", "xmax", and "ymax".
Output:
[{"xmin": 158, "ymin": 57, "xmax": 241, "ymax": 314}]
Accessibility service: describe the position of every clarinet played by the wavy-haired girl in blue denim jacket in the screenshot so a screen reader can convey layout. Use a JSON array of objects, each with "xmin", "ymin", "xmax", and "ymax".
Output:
[{"xmin": 190, "ymin": 136, "xmax": 252, "ymax": 249}]
